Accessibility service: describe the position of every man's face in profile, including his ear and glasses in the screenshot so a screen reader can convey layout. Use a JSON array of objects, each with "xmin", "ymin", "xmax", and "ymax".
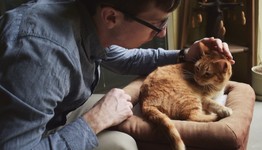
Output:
[{"xmin": 98, "ymin": 6, "xmax": 168, "ymax": 48}]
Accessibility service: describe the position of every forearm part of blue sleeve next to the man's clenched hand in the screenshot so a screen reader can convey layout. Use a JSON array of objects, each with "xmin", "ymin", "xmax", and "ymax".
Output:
[{"xmin": 33, "ymin": 117, "xmax": 98, "ymax": 150}]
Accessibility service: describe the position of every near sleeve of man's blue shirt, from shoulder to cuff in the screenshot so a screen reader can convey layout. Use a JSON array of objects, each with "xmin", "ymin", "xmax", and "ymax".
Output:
[{"xmin": 0, "ymin": 34, "xmax": 98, "ymax": 150}]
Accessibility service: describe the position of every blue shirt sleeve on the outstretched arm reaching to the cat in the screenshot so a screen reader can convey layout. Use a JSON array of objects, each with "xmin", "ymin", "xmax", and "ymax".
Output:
[{"xmin": 102, "ymin": 45, "xmax": 179, "ymax": 75}]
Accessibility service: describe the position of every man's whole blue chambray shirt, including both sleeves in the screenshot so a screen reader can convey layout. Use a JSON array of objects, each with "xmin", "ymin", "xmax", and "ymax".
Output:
[{"xmin": 0, "ymin": 0, "xmax": 180, "ymax": 150}]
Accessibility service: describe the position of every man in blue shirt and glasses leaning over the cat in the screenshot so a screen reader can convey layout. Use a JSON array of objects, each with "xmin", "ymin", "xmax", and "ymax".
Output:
[{"xmin": 0, "ymin": 0, "xmax": 234, "ymax": 150}]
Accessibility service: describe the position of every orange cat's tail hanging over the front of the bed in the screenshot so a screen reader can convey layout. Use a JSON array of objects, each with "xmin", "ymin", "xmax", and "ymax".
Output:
[{"xmin": 142, "ymin": 106, "xmax": 186, "ymax": 150}]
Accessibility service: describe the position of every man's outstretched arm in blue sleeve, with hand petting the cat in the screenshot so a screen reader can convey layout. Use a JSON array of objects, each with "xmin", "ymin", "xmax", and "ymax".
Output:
[{"xmin": 102, "ymin": 37, "xmax": 235, "ymax": 75}]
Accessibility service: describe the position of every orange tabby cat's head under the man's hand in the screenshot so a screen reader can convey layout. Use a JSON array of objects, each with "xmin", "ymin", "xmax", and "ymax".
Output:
[{"xmin": 194, "ymin": 50, "xmax": 232, "ymax": 86}]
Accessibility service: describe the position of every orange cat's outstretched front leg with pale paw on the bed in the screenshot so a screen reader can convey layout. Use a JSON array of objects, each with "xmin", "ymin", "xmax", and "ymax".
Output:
[{"xmin": 203, "ymin": 98, "xmax": 233, "ymax": 118}]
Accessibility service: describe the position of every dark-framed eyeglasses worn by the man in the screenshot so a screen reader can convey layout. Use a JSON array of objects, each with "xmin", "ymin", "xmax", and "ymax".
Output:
[{"xmin": 102, "ymin": 5, "xmax": 168, "ymax": 36}]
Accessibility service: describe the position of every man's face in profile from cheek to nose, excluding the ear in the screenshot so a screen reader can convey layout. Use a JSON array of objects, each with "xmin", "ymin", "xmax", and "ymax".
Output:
[{"xmin": 113, "ymin": 9, "xmax": 168, "ymax": 48}]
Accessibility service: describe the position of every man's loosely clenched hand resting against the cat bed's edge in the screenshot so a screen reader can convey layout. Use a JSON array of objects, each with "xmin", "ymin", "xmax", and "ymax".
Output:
[{"xmin": 83, "ymin": 88, "xmax": 133, "ymax": 133}]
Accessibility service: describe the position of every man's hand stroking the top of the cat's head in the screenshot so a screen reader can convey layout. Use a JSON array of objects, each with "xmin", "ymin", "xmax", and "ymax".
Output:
[{"xmin": 185, "ymin": 37, "xmax": 235, "ymax": 64}]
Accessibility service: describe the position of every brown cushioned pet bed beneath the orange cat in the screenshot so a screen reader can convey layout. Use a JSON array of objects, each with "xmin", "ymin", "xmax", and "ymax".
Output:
[{"xmin": 116, "ymin": 79, "xmax": 255, "ymax": 150}]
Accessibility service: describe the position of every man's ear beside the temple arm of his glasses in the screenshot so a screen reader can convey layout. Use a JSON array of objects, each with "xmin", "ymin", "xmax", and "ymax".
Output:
[{"xmin": 101, "ymin": 7, "xmax": 119, "ymax": 29}]
